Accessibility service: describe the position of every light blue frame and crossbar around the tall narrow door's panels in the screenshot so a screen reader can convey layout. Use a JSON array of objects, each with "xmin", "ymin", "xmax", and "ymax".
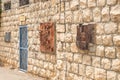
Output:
[{"xmin": 19, "ymin": 25, "xmax": 28, "ymax": 72}]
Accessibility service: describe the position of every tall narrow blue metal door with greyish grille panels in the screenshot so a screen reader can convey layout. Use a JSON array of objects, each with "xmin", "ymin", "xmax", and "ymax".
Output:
[{"xmin": 20, "ymin": 27, "xmax": 28, "ymax": 71}]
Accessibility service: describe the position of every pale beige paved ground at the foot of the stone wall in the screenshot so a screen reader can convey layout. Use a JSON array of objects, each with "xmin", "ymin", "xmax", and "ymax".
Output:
[{"xmin": 0, "ymin": 67, "xmax": 43, "ymax": 80}]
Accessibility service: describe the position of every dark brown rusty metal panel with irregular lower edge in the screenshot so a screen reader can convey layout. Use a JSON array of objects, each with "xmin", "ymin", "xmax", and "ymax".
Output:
[{"xmin": 76, "ymin": 24, "xmax": 94, "ymax": 50}]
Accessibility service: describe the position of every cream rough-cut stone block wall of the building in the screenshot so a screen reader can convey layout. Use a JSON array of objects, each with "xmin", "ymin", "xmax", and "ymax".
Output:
[{"xmin": 0, "ymin": 0, "xmax": 120, "ymax": 80}]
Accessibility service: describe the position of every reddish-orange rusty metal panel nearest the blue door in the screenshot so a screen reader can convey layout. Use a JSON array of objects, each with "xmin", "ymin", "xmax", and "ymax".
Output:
[{"xmin": 40, "ymin": 22, "xmax": 55, "ymax": 53}]
